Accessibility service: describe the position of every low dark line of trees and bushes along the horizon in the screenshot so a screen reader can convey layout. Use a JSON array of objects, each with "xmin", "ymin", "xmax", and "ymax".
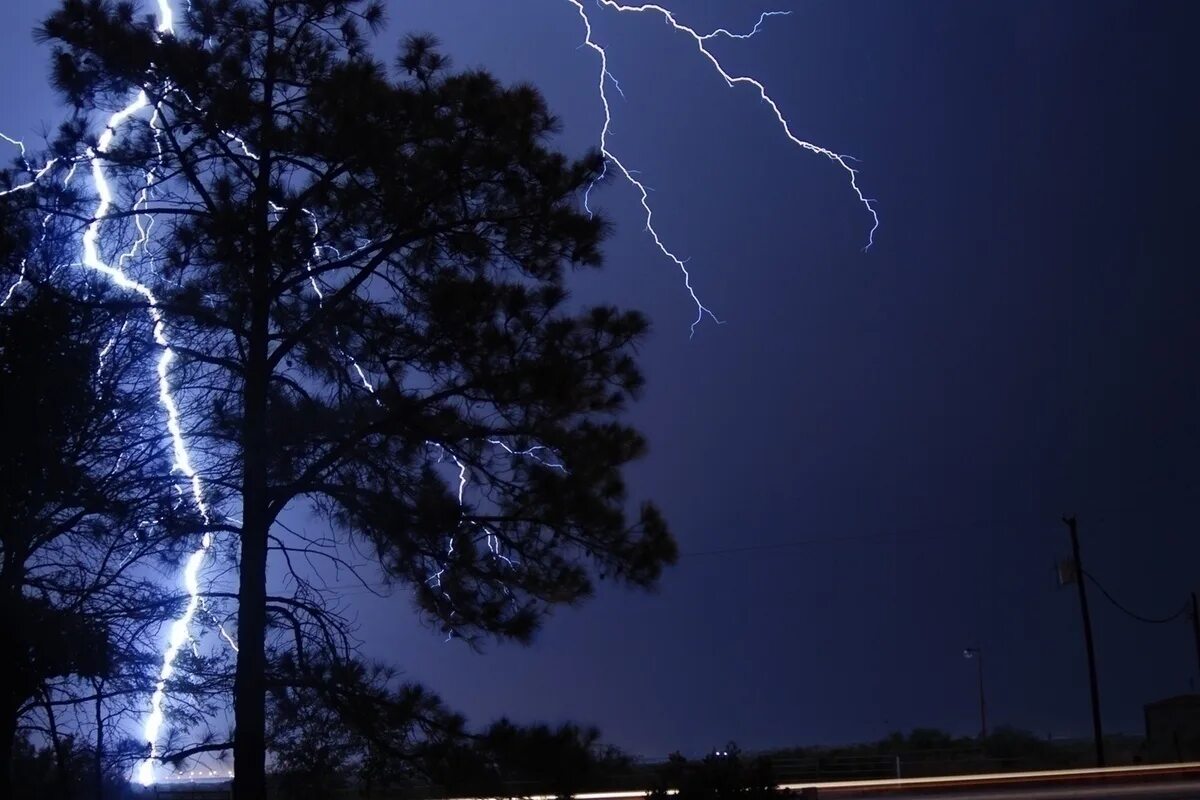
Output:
[{"xmin": 4, "ymin": 719, "xmax": 1156, "ymax": 800}]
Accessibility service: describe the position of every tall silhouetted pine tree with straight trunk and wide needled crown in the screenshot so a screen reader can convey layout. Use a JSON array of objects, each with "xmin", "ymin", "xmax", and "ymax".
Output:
[{"xmin": 32, "ymin": 0, "xmax": 676, "ymax": 799}]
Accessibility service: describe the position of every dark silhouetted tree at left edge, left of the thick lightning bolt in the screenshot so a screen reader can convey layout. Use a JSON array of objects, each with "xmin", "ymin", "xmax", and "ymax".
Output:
[{"xmin": 0, "ymin": 272, "xmax": 210, "ymax": 794}]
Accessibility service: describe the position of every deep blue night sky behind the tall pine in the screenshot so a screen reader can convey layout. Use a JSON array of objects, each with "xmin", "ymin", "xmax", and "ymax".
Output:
[{"xmin": 0, "ymin": 0, "xmax": 1200, "ymax": 756}]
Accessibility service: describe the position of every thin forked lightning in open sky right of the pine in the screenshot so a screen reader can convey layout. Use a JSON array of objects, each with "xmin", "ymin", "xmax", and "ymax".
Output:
[{"xmin": 566, "ymin": 0, "xmax": 880, "ymax": 335}]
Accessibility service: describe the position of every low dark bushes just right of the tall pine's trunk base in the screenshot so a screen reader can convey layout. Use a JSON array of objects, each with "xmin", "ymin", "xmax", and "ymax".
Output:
[{"xmin": 268, "ymin": 658, "xmax": 634, "ymax": 800}]
